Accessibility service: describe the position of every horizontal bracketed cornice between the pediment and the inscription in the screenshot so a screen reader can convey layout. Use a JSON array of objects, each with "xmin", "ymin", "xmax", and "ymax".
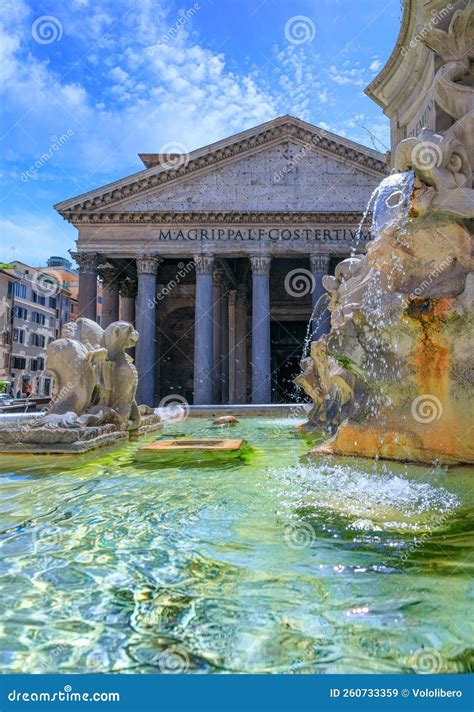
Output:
[{"xmin": 68, "ymin": 210, "xmax": 362, "ymax": 226}]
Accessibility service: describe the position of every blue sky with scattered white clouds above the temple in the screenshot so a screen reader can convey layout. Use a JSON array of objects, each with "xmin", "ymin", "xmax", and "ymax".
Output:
[{"xmin": 0, "ymin": 0, "xmax": 401, "ymax": 266}]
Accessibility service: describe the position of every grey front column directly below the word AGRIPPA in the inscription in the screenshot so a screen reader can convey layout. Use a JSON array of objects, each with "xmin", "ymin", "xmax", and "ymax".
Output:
[{"xmin": 194, "ymin": 255, "xmax": 214, "ymax": 405}]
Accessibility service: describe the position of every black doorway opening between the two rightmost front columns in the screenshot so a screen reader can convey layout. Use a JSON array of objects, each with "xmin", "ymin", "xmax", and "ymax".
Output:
[{"xmin": 271, "ymin": 321, "xmax": 308, "ymax": 403}]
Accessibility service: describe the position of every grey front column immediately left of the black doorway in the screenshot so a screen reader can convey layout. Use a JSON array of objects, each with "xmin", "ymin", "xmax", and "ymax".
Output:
[{"xmin": 250, "ymin": 255, "xmax": 272, "ymax": 403}]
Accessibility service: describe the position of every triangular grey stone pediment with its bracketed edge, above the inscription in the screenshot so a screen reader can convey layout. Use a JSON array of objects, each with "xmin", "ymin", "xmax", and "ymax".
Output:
[{"xmin": 55, "ymin": 116, "xmax": 387, "ymax": 221}]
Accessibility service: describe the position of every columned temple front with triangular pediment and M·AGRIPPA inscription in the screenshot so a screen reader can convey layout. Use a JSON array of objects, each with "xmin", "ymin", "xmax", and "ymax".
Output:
[{"xmin": 55, "ymin": 116, "xmax": 387, "ymax": 405}]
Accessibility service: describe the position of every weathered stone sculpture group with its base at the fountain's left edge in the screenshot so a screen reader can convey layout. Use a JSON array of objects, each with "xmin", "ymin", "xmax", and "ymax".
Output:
[{"xmin": 0, "ymin": 318, "xmax": 161, "ymax": 454}]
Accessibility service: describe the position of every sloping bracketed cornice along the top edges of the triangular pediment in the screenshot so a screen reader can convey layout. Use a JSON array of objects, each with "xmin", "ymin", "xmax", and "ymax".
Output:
[{"xmin": 55, "ymin": 117, "xmax": 387, "ymax": 217}]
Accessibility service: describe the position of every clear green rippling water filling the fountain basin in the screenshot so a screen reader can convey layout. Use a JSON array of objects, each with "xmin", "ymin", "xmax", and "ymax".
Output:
[{"xmin": 0, "ymin": 418, "xmax": 474, "ymax": 673}]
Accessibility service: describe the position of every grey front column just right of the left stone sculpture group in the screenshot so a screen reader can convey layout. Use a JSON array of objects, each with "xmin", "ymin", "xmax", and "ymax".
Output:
[{"xmin": 135, "ymin": 255, "xmax": 161, "ymax": 407}]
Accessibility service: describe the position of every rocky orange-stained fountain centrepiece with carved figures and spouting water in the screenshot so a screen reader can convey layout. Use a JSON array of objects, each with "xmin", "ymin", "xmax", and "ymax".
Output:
[{"xmin": 295, "ymin": 2, "xmax": 474, "ymax": 464}]
